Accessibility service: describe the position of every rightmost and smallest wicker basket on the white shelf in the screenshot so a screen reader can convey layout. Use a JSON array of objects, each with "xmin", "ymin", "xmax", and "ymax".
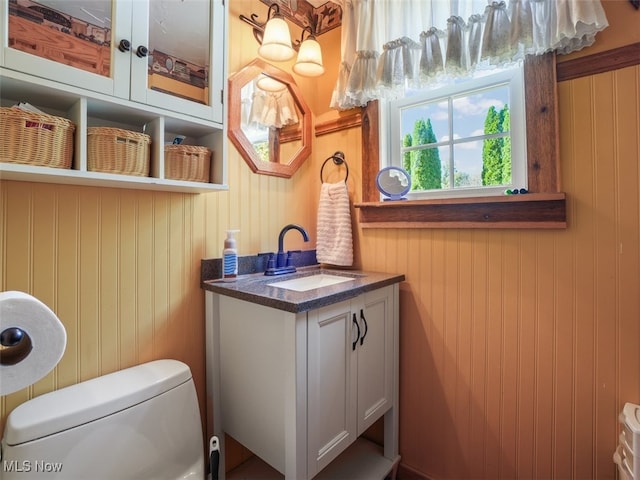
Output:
[{"xmin": 164, "ymin": 145, "xmax": 211, "ymax": 182}]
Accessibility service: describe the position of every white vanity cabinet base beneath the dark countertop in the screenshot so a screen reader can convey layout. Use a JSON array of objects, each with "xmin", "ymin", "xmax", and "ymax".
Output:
[{"xmin": 206, "ymin": 283, "xmax": 399, "ymax": 480}]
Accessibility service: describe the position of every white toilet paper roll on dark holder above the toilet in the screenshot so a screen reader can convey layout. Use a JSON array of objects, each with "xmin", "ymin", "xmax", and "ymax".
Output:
[{"xmin": 0, "ymin": 291, "xmax": 67, "ymax": 395}]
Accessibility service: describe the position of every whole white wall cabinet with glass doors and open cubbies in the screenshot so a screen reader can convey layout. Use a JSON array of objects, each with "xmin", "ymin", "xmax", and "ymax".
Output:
[{"xmin": 0, "ymin": 0, "xmax": 227, "ymax": 192}]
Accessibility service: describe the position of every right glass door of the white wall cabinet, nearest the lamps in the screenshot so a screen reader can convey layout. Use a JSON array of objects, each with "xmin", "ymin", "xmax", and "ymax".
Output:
[{"xmin": 131, "ymin": 0, "xmax": 224, "ymax": 122}]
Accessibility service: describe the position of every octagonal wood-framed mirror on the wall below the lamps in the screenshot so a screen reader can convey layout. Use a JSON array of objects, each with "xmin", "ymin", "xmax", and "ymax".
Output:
[{"xmin": 228, "ymin": 58, "xmax": 312, "ymax": 178}]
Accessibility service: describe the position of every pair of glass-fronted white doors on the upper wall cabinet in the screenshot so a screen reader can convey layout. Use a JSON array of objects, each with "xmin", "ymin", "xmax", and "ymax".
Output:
[{"xmin": 0, "ymin": 0, "xmax": 225, "ymax": 124}]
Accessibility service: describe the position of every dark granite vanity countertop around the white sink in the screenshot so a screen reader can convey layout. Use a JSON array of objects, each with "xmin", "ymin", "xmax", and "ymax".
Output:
[{"xmin": 202, "ymin": 265, "xmax": 405, "ymax": 313}]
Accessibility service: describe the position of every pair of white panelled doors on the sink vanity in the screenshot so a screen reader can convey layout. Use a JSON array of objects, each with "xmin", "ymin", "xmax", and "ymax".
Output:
[{"xmin": 307, "ymin": 287, "xmax": 394, "ymax": 476}]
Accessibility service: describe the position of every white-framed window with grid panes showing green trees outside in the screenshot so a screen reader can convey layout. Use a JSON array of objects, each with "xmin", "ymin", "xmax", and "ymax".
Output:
[{"xmin": 381, "ymin": 67, "xmax": 527, "ymax": 199}]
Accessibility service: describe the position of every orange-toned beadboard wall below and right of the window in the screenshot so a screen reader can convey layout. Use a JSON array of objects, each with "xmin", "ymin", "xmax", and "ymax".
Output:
[{"xmin": 359, "ymin": 62, "xmax": 640, "ymax": 479}]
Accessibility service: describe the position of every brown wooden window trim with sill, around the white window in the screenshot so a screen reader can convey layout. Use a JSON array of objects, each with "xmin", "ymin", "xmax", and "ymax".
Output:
[{"xmin": 354, "ymin": 53, "xmax": 567, "ymax": 228}]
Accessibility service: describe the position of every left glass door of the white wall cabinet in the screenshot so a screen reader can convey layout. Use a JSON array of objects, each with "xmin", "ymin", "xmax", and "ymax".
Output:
[{"xmin": 2, "ymin": 0, "xmax": 131, "ymax": 96}]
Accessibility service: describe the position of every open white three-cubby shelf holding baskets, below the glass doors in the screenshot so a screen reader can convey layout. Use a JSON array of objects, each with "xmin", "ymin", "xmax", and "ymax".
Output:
[{"xmin": 0, "ymin": 68, "xmax": 228, "ymax": 193}]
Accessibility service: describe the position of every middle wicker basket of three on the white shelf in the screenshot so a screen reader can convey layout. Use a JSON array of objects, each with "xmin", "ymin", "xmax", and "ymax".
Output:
[{"xmin": 87, "ymin": 127, "xmax": 151, "ymax": 177}]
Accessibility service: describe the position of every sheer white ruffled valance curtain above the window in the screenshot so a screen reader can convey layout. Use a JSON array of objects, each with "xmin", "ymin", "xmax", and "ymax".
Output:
[{"xmin": 331, "ymin": 0, "xmax": 608, "ymax": 110}]
